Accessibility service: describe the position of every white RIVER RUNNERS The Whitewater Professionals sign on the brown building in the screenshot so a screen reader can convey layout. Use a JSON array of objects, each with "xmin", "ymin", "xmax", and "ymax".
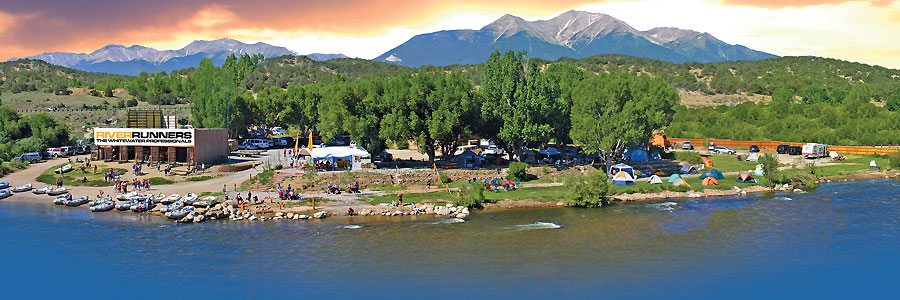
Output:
[{"xmin": 94, "ymin": 128, "xmax": 194, "ymax": 147}]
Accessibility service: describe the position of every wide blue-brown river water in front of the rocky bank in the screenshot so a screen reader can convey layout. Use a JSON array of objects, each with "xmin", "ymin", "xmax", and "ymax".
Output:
[{"xmin": 0, "ymin": 179, "xmax": 900, "ymax": 299}]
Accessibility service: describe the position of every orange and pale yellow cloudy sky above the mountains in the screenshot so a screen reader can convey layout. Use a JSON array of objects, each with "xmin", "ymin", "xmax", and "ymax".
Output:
[{"xmin": 0, "ymin": 0, "xmax": 900, "ymax": 68}]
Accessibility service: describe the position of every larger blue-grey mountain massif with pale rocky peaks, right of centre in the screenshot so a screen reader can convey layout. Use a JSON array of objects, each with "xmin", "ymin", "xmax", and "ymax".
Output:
[{"xmin": 375, "ymin": 10, "xmax": 776, "ymax": 67}]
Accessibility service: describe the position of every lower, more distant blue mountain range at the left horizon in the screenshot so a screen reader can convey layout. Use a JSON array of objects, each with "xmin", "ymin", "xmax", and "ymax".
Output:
[{"xmin": 11, "ymin": 38, "xmax": 346, "ymax": 75}]
